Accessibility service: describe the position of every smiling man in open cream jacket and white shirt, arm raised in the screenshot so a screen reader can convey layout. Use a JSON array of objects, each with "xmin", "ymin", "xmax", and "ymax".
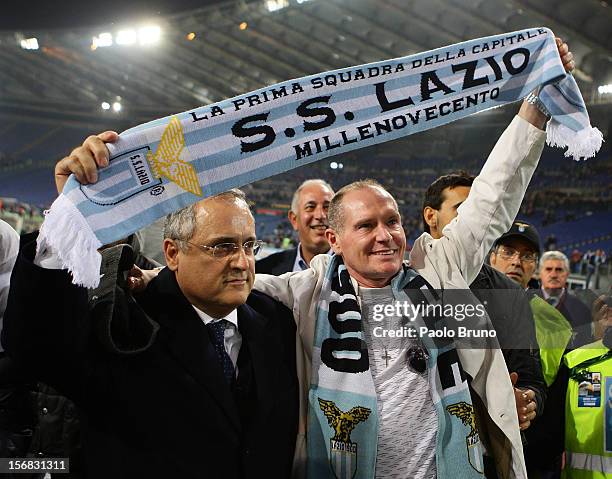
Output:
[{"xmin": 255, "ymin": 61, "xmax": 571, "ymax": 478}]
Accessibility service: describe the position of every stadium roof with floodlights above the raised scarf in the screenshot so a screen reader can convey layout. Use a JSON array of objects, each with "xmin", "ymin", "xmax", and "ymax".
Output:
[{"xmin": 0, "ymin": 0, "xmax": 612, "ymax": 124}]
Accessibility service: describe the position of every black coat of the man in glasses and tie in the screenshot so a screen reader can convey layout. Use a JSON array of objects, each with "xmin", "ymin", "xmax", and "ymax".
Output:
[{"xmin": 3, "ymin": 245, "xmax": 298, "ymax": 478}]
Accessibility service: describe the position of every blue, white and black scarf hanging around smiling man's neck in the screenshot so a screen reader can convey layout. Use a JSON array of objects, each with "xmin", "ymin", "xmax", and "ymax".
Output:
[{"xmin": 307, "ymin": 256, "xmax": 483, "ymax": 479}]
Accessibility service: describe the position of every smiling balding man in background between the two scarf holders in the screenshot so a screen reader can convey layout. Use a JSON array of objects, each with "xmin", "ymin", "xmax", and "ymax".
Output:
[{"xmin": 255, "ymin": 179, "xmax": 334, "ymax": 275}]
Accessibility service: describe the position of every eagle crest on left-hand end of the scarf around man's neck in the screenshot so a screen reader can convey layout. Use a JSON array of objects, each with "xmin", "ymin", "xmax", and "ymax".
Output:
[{"xmin": 318, "ymin": 398, "xmax": 372, "ymax": 479}]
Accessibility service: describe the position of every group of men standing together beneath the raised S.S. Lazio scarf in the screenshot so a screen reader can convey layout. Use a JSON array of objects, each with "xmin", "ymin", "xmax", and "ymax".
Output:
[{"xmin": 0, "ymin": 37, "xmax": 612, "ymax": 479}]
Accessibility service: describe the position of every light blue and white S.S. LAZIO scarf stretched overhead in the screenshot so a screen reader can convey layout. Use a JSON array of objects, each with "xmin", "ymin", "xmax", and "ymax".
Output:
[{"xmin": 39, "ymin": 28, "xmax": 602, "ymax": 287}]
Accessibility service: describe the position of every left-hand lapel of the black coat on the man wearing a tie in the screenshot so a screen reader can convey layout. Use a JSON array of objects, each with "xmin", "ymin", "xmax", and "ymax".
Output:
[{"xmin": 145, "ymin": 268, "xmax": 241, "ymax": 430}]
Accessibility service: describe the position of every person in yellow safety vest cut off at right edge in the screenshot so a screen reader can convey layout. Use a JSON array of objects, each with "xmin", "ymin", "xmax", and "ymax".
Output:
[{"xmin": 563, "ymin": 296, "xmax": 612, "ymax": 479}]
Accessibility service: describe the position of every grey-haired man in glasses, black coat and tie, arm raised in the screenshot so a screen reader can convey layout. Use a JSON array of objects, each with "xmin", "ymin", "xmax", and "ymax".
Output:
[{"xmin": 3, "ymin": 191, "xmax": 298, "ymax": 478}]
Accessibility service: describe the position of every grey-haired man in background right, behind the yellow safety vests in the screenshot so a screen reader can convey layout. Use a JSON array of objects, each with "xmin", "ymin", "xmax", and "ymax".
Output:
[{"xmin": 536, "ymin": 251, "xmax": 595, "ymax": 349}]
